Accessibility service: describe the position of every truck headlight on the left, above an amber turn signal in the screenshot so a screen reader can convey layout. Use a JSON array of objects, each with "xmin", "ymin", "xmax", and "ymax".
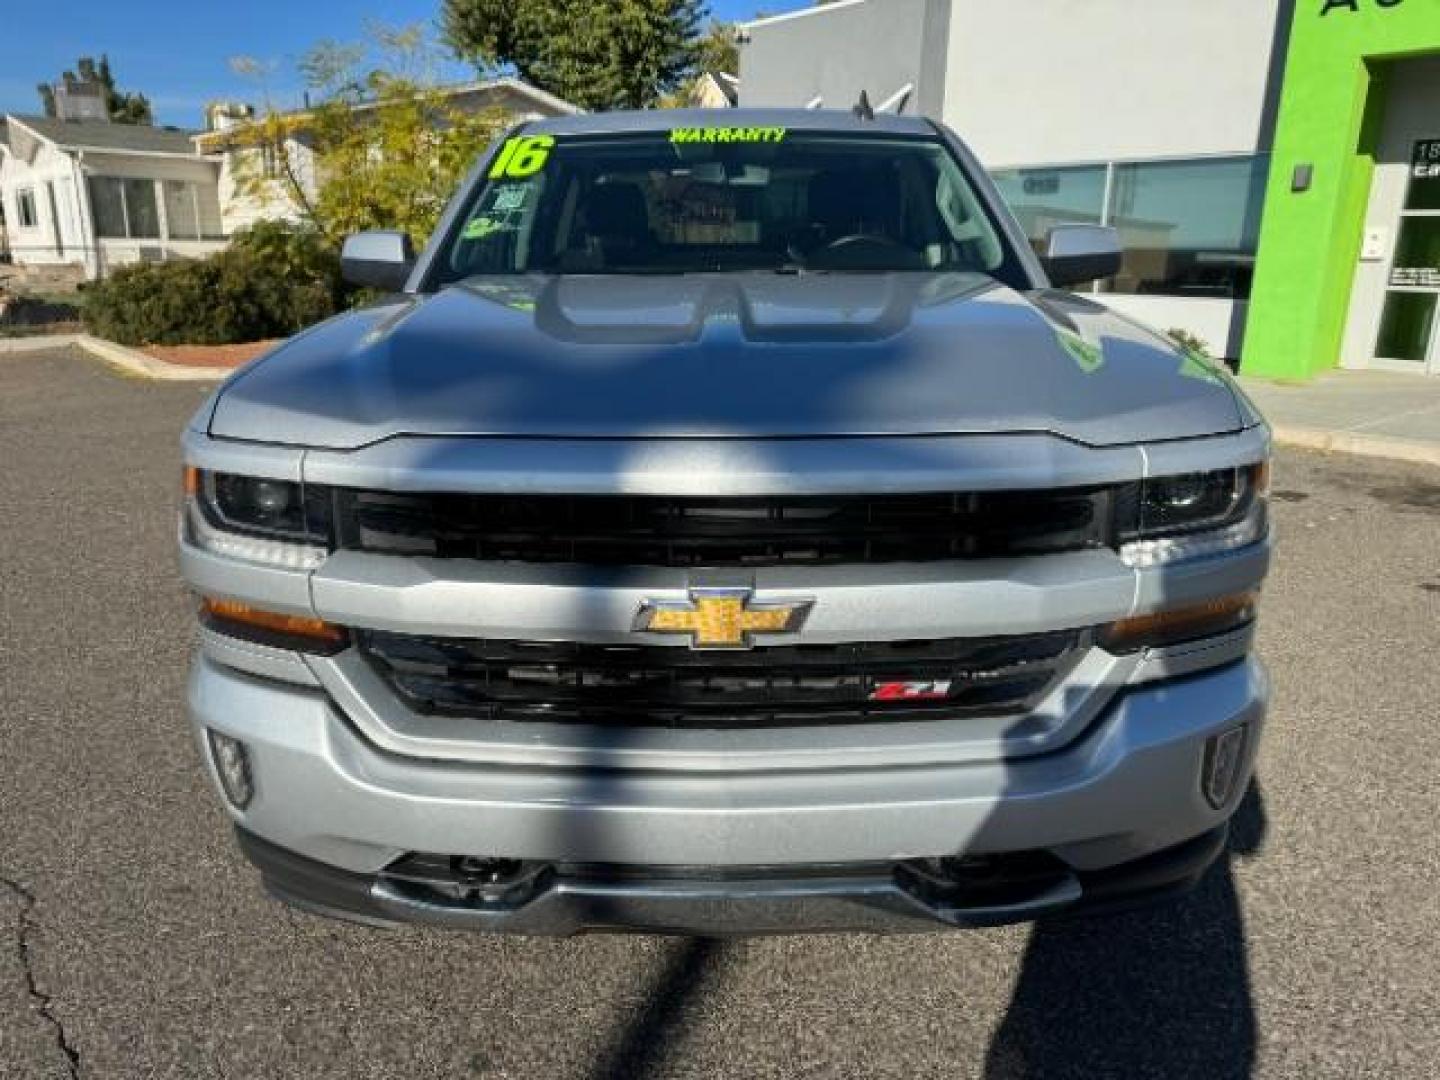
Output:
[{"xmin": 184, "ymin": 468, "xmax": 331, "ymax": 570}]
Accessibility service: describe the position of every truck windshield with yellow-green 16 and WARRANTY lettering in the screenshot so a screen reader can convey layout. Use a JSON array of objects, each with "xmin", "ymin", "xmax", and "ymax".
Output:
[{"xmin": 433, "ymin": 127, "xmax": 1024, "ymax": 285}]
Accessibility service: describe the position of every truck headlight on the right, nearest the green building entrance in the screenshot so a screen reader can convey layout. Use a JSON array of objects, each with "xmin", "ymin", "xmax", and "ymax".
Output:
[{"xmin": 1120, "ymin": 464, "xmax": 1269, "ymax": 567}]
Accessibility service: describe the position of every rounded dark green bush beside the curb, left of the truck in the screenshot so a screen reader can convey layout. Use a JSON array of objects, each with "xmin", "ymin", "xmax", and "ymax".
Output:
[{"xmin": 85, "ymin": 222, "xmax": 346, "ymax": 346}]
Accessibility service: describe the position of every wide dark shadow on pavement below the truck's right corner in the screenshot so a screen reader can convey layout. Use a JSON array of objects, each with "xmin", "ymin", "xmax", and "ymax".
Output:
[{"xmin": 985, "ymin": 783, "xmax": 1266, "ymax": 1080}]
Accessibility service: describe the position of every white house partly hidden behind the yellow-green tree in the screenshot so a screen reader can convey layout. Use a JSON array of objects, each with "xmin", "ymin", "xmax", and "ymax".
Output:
[{"xmin": 192, "ymin": 78, "xmax": 580, "ymax": 235}]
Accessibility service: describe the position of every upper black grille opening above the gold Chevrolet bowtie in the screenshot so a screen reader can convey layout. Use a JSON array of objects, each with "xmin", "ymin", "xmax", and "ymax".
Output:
[{"xmin": 337, "ymin": 488, "xmax": 1113, "ymax": 567}]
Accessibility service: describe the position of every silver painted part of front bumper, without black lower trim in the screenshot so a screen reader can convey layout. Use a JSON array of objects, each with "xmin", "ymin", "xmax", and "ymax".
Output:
[{"xmin": 190, "ymin": 655, "xmax": 1267, "ymax": 874}]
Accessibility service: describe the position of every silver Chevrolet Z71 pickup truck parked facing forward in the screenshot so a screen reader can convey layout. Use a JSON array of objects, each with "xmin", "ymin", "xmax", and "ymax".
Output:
[{"xmin": 180, "ymin": 109, "xmax": 1270, "ymax": 935}]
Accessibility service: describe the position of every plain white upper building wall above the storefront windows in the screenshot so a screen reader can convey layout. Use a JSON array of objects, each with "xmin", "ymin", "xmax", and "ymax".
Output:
[{"xmin": 944, "ymin": 0, "xmax": 1284, "ymax": 168}]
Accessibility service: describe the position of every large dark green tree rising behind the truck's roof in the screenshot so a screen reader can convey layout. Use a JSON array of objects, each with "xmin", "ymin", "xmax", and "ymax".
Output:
[{"xmin": 441, "ymin": 0, "xmax": 707, "ymax": 109}]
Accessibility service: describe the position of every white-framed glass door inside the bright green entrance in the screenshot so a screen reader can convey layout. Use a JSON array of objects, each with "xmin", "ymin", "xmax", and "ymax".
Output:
[{"xmin": 1374, "ymin": 132, "xmax": 1440, "ymax": 374}]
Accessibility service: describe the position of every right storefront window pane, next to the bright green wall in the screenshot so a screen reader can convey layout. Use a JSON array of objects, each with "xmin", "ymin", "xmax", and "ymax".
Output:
[{"xmin": 1107, "ymin": 157, "xmax": 1269, "ymax": 300}]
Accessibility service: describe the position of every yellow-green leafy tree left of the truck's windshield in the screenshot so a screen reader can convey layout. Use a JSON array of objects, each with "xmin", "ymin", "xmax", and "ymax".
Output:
[{"xmin": 228, "ymin": 26, "xmax": 505, "ymax": 248}]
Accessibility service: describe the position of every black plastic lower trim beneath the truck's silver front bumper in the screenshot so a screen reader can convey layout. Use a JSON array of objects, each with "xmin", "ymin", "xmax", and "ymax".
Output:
[{"xmin": 236, "ymin": 825, "xmax": 1228, "ymax": 936}]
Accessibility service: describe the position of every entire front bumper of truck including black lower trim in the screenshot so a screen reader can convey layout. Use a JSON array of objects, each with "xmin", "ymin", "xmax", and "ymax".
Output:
[{"xmin": 190, "ymin": 655, "xmax": 1267, "ymax": 933}]
